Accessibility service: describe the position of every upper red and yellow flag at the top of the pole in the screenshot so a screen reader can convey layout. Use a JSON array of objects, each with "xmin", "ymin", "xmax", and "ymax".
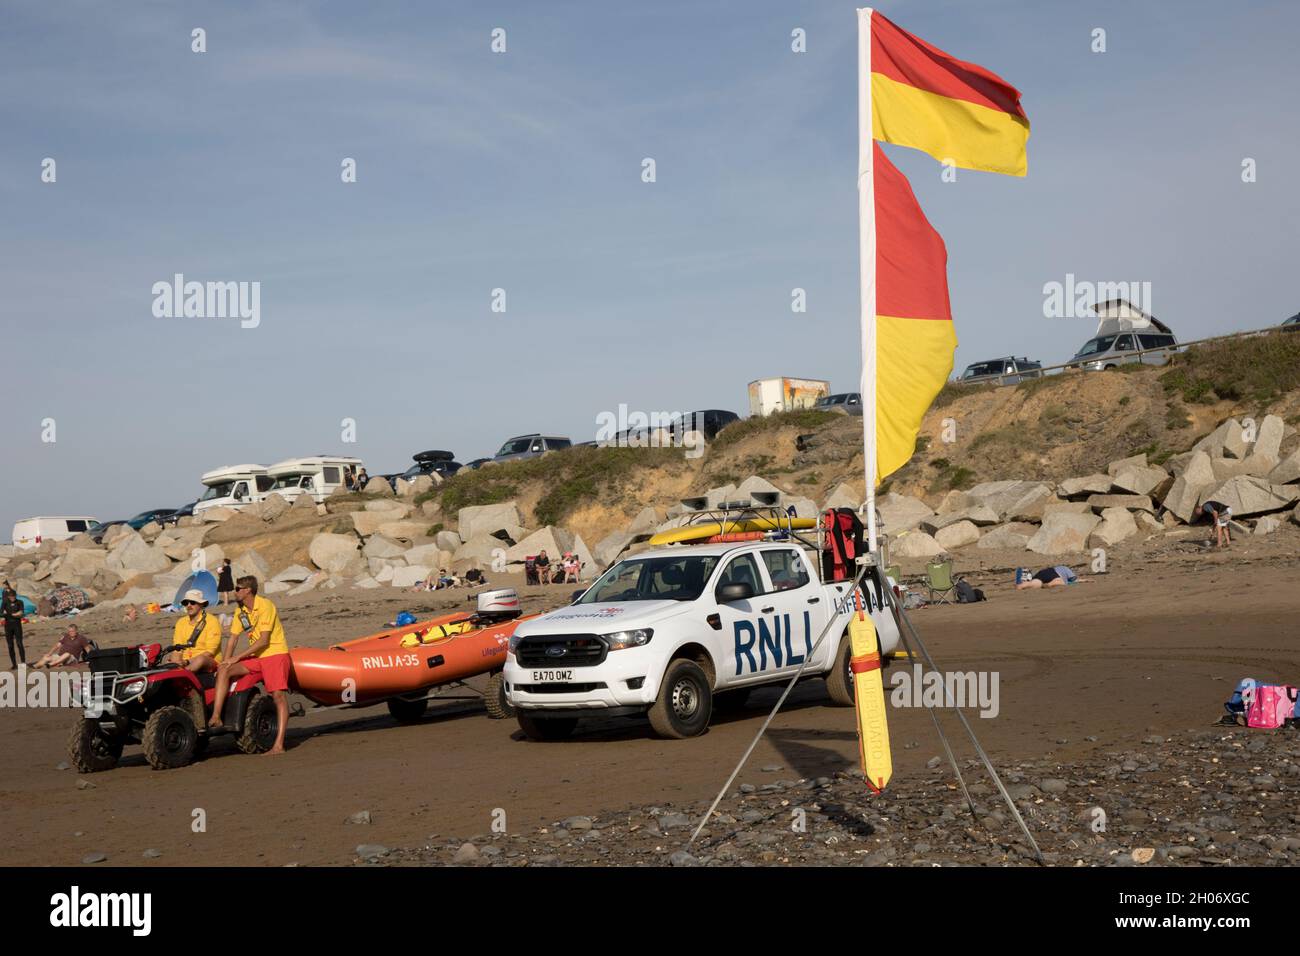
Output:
[{"xmin": 870, "ymin": 10, "xmax": 1030, "ymax": 176}]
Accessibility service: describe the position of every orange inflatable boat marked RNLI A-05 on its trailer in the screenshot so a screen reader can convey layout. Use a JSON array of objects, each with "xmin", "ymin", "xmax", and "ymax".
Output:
[{"xmin": 289, "ymin": 588, "xmax": 524, "ymax": 721}]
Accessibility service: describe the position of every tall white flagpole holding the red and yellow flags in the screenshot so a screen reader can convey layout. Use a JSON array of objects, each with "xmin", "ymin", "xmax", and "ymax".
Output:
[{"xmin": 858, "ymin": 7, "xmax": 876, "ymax": 553}]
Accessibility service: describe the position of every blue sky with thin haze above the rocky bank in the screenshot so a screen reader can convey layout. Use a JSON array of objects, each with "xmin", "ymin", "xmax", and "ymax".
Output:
[{"xmin": 0, "ymin": 0, "xmax": 1300, "ymax": 540}]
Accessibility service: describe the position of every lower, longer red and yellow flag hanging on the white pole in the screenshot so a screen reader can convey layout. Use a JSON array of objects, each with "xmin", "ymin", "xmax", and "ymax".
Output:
[{"xmin": 871, "ymin": 143, "xmax": 957, "ymax": 484}]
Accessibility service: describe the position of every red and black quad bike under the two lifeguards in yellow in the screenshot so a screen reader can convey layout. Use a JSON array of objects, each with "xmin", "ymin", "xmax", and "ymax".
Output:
[{"xmin": 68, "ymin": 644, "xmax": 278, "ymax": 774}]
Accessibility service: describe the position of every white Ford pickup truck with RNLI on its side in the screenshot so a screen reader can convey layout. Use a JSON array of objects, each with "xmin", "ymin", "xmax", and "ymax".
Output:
[{"xmin": 504, "ymin": 540, "xmax": 898, "ymax": 740}]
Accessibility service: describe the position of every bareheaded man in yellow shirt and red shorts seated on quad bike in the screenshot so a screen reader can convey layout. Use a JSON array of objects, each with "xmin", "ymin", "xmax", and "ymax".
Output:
[{"xmin": 208, "ymin": 575, "xmax": 291, "ymax": 754}]
